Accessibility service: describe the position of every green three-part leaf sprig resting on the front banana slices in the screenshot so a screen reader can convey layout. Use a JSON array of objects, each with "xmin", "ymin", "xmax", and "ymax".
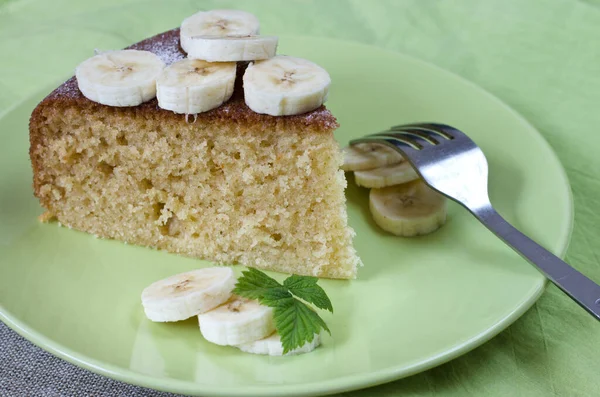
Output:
[{"xmin": 233, "ymin": 268, "xmax": 333, "ymax": 354}]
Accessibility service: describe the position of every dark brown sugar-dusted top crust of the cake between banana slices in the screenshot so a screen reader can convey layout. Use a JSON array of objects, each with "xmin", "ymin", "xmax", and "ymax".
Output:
[{"xmin": 42, "ymin": 28, "xmax": 338, "ymax": 131}]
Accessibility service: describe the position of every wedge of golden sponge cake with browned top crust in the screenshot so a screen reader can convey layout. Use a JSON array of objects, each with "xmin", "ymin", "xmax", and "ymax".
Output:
[{"xmin": 29, "ymin": 29, "xmax": 359, "ymax": 278}]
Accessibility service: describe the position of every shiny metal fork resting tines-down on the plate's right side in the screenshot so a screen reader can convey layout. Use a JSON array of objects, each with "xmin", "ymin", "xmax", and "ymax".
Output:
[{"xmin": 350, "ymin": 123, "xmax": 600, "ymax": 320}]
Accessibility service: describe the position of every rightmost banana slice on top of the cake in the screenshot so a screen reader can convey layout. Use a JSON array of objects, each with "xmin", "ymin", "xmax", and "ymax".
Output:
[{"xmin": 244, "ymin": 55, "xmax": 331, "ymax": 116}]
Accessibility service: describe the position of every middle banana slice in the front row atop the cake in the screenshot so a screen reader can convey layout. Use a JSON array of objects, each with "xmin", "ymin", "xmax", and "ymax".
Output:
[{"xmin": 156, "ymin": 59, "xmax": 236, "ymax": 114}]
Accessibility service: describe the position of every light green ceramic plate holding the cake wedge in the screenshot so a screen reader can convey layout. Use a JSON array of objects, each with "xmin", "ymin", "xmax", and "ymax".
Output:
[{"xmin": 0, "ymin": 37, "xmax": 572, "ymax": 396}]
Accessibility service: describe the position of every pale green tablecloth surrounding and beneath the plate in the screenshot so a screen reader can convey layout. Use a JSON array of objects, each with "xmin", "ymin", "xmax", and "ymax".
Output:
[{"xmin": 0, "ymin": 0, "xmax": 600, "ymax": 397}]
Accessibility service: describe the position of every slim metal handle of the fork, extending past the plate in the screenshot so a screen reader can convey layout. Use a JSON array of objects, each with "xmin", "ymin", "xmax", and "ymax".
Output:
[{"xmin": 473, "ymin": 206, "xmax": 600, "ymax": 320}]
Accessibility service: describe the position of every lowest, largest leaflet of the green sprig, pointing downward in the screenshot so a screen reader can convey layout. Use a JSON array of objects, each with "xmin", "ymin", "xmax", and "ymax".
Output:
[{"xmin": 273, "ymin": 296, "xmax": 331, "ymax": 354}]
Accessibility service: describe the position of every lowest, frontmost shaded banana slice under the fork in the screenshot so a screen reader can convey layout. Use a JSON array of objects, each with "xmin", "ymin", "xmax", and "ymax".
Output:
[{"xmin": 369, "ymin": 180, "xmax": 446, "ymax": 237}]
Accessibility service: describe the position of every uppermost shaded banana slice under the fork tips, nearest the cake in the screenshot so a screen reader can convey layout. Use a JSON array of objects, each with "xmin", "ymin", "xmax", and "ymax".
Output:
[{"xmin": 342, "ymin": 143, "xmax": 404, "ymax": 171}]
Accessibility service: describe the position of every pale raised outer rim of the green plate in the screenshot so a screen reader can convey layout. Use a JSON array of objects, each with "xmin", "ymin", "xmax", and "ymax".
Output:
[{"xmin": 0, "ymin": 35, "xmax": 574, "ymax": 397}]
